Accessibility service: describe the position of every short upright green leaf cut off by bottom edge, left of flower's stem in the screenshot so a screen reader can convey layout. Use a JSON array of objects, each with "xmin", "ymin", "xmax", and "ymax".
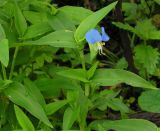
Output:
[{"xmin": 63, "ymin": 107, "xmax": 79, "ymax": 130}]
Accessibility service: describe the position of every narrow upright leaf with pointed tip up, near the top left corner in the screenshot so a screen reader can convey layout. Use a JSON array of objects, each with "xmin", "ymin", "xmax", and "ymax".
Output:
[{"xmin": 14, "ymin": 3, "xmax": 27, "ymax": 37}]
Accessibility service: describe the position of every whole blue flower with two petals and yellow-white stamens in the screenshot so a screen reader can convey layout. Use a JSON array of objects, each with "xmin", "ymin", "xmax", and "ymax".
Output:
[{"xmin": 85, "ymin": 27, "xmax": 110, "ymax": 55}]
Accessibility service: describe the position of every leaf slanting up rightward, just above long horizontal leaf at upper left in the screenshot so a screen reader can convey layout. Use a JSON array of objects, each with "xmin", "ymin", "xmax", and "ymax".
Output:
[{"xmin": 21, "ymin": 22, "xmax": 52, "ymax": 39}]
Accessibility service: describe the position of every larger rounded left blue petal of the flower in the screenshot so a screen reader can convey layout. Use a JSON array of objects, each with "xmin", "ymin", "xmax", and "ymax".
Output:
[{"xmin": 85, "ymin": 29, "xmax": 102, "ymax": 44}]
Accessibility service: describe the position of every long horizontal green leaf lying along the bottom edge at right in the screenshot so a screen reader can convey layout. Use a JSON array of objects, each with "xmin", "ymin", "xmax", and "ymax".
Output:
[{"xmin": 90, "ymin": 119, "xmax": 158, "ymax": 131}]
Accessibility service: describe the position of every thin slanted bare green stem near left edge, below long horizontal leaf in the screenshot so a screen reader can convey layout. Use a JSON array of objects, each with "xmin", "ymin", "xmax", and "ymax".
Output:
[{"xmin": 9, "ymin": 47, "xmax": 19, "ymax": 79}]
